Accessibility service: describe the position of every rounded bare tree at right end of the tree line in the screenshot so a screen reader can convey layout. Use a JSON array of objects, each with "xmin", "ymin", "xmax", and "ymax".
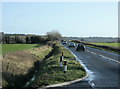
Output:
[{"xmin": 47, "ymin": 30, "xmax": 62, "ymax": 41}]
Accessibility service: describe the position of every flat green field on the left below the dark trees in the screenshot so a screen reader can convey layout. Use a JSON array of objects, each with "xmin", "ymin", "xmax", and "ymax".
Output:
[{"xmin": 1, "ymin": 44, "xmax": 40, "ymax": 55}]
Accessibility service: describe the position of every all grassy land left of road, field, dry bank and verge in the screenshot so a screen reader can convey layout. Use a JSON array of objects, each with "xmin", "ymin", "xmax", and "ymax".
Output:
[{"xmin": 2, "ymin": 42, "xmax": 86, "ymax": 89}]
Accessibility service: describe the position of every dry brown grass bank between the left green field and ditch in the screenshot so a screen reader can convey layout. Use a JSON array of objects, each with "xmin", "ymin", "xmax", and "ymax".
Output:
[{"xmin": 2, "ymin": 44, "xmax": 52, "ymax": 89}]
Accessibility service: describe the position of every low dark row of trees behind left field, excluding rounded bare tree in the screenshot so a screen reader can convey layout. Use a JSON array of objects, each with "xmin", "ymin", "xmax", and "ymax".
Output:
[{"xmin": 0, "ymin": 34, "xmax": 47, "ymax": 44}]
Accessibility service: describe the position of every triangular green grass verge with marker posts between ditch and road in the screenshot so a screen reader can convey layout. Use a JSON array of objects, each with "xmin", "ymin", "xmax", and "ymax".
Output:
[{"xmin": 28, "ymin": 42, "xmax": 86, "ymax": 88}]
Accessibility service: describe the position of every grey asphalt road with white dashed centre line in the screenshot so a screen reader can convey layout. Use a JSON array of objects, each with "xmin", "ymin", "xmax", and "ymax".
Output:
[{"xmin": 56, "ymin": 44, "xmax": 120, "ymax": 89}]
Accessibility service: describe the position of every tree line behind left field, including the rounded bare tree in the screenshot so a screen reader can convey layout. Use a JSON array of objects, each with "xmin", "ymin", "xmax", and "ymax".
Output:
[{"xmin": 0, "ymin": 31, "xmax": 62, "ymax": 44}]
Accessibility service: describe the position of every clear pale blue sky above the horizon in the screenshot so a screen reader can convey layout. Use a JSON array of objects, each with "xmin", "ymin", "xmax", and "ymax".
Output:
[{"xmin": 2, "ymin": 2, "xmax": 118, "ymax": 37}]
